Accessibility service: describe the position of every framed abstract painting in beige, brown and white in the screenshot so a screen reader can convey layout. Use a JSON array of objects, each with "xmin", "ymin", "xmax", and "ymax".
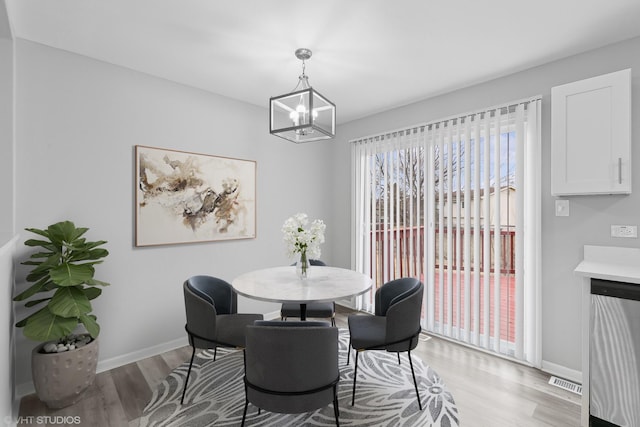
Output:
[{"xmin": 135, "ymin": 145, "xmax": 256, "ymax": 246}]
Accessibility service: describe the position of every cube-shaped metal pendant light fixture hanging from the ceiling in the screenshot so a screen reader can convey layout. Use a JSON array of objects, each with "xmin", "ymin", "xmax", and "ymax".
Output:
[{"xmin": 269, "ymin": 48, "xmax": 336, "ymax": 143}]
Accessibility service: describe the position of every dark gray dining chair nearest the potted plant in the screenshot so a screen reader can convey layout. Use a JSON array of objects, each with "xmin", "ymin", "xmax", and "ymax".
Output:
[{"xmin": 180, "ymin": 275, "xmax": 263, "ymax": 404}]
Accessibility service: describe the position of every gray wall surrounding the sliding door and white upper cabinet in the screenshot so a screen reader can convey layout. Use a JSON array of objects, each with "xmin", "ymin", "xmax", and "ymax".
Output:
[{"xmin": 332, "ymin": 38, "xmax": 640, "ymax": 374}]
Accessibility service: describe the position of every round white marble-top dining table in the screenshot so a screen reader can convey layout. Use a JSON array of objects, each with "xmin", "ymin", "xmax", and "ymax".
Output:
[{"xmin": 231, "ymin": 265, "xmax": 373, "ymax": 320}]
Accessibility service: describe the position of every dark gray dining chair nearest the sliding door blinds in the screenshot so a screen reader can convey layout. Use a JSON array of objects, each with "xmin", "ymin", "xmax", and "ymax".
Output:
[{"xmin": 347, "ymin": 277, "xmax": 424, "ymax": 410}]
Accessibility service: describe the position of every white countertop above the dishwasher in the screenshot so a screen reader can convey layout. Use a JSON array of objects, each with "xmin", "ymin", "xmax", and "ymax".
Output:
[{"xmin": 574, "ymin": 245, "xmax": 640, "ymax": 284}]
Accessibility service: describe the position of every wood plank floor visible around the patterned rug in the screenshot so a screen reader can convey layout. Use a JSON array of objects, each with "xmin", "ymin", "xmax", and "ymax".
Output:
[{"xmin": 18, "ymin": 307, "xmax": 580, "ymax": 427}]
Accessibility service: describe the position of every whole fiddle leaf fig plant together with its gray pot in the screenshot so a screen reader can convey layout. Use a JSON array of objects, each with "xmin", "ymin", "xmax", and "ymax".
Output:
[{"xmin": 13, "ymin": 221, "xmax": 109, "ymax": 408}]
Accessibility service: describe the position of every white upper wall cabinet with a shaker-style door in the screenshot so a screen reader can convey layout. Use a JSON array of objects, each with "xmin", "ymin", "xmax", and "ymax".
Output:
[{"xmin": 551, "ymin": 69, "xmax": 631, "ymax": 196}]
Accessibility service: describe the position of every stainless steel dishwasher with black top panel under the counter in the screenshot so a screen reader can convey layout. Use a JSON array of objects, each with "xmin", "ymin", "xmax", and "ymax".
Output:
[{"xmin": 589, "ymin": 279, "xmax": 640, "ymax": 427}]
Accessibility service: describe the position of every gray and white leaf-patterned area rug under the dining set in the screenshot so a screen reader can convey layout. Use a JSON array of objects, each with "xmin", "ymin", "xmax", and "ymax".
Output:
[{"xmin": 140, "ymin": 330, "xmax": 459, "ymax": 427}]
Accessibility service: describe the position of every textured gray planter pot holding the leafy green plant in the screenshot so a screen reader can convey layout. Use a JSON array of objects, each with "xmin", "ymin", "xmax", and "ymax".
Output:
[{"xmin": 31, "ymin": 339, "xmax": 98, "ymax": 408}]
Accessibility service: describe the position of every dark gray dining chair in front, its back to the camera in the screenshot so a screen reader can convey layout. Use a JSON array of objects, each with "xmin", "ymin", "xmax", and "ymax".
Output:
[{"xmin": 242, "ymin": 321, "xmax": 340, "ymax": 426}]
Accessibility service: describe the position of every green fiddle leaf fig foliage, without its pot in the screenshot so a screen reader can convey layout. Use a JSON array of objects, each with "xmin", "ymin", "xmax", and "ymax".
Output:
[{"xmin": 13, "ymin": 221, "xmax": 109, "ymax": 341}]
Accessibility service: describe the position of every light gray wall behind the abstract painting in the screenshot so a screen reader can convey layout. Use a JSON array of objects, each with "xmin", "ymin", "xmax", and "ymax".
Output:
[{"xmin": 16, "ymin": 40, "xmax": 334, "ymax": 387}]
